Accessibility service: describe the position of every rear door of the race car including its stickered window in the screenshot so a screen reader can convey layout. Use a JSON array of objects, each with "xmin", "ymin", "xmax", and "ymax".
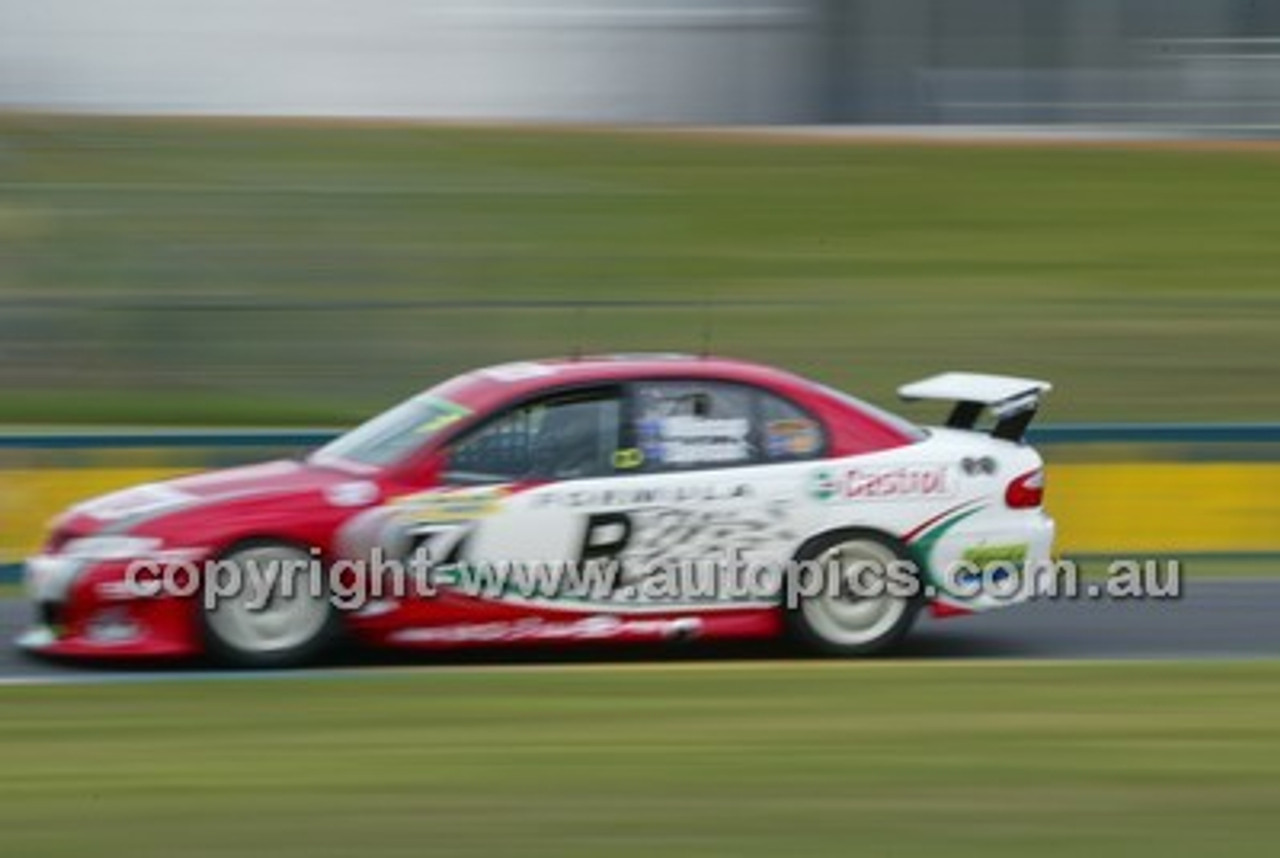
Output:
[{"xmin": 568, "ymin": 379, "xmax": 826, "ymax": 608}]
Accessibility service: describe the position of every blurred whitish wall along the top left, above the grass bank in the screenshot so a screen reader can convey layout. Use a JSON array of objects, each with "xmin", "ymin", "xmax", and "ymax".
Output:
[{"xmin": 0, "ymin": 0, "xmax": 819, "ymax": 123}]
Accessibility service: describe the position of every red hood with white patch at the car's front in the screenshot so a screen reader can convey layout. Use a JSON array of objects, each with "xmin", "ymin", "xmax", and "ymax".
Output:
[{"xmin": 58, "ymin": 460, "xmax": 379, "ymax": 535}]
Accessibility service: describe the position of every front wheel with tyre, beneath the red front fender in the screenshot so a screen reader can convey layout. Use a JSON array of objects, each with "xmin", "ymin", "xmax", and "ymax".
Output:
[{"xmin": 200, "ymin": 540, "xmax": 342, "ymax": 670}]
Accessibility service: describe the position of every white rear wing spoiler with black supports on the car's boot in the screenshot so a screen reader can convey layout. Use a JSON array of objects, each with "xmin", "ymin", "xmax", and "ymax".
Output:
[{"xmin": 897, "ymin": 373, "xmax": 1053, "ymax": 441}]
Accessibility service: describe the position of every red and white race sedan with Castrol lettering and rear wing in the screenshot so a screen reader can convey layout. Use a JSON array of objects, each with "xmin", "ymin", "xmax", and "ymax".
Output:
[{"xmin": 19, "ymin": 355, "xmax": 1053, "ymax": 666}]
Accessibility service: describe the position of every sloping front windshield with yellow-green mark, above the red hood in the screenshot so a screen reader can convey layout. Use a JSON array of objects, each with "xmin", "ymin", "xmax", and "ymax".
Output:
[{"xmin": 312, "ymin": 393, "xmax": 470, "ymax": 467}]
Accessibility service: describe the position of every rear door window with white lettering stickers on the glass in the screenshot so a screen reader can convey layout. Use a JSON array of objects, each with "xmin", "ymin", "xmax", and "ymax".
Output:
[{"xmin": 632, "ymin": 382, "xmax": 759, "ymax": 471}]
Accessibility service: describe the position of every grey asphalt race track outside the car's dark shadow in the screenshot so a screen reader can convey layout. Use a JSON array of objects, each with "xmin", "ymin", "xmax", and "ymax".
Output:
[{"xmin": 0, "ymin": 578, "xmax": 1280, "ymax": 684}]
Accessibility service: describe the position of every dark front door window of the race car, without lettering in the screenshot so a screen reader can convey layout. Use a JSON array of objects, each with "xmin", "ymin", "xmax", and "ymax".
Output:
[{"xmin": 445, "ymin": 391, "xmax": 621, "ymax": 483}]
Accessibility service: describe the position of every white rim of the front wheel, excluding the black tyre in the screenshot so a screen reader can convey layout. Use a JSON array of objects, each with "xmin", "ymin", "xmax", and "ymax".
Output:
[{"xmin": 207, "ymin": 546, "xmax": 329, "ymax": 653}]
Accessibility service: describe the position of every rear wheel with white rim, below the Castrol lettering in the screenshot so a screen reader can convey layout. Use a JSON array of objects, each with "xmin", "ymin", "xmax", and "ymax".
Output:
[{"xmin": 783, "ymin": 534, "xmax": 922, "ymax": 656}]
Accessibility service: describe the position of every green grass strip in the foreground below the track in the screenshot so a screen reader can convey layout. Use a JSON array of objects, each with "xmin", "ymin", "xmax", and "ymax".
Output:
[{"xmin": 0, "ymin": 662, "xmax": 1280, "ymax": 858}]
